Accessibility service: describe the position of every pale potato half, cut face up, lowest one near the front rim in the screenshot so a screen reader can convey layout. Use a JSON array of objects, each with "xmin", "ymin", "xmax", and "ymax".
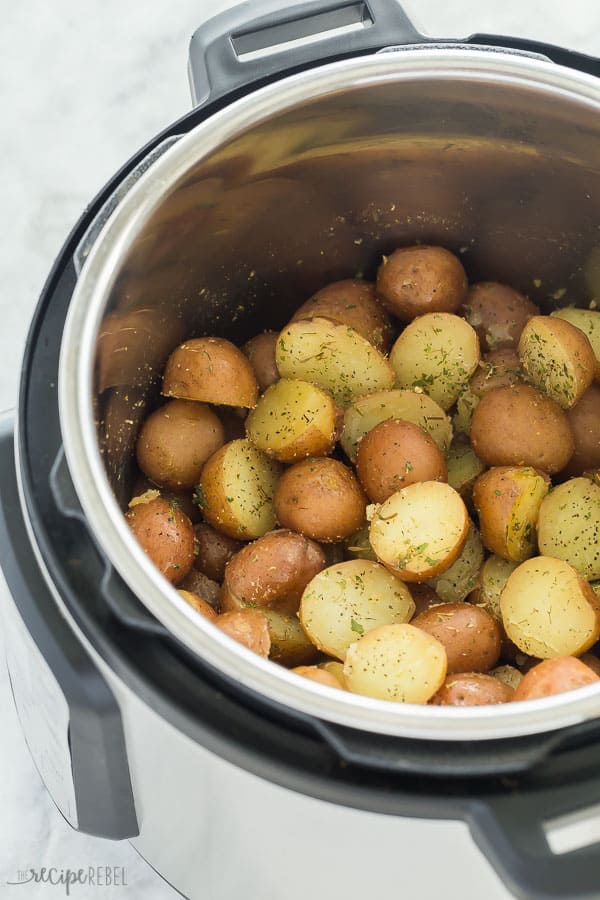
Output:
[{"xmin": 344, "ymin": 624, "xmax": 446, "ymax": 703}]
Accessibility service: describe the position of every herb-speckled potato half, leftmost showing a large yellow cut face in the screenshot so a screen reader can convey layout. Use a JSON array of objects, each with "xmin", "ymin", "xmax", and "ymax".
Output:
[{"xmin": 196, "ymin": 440, "xmax": 281, "ymax": 541}]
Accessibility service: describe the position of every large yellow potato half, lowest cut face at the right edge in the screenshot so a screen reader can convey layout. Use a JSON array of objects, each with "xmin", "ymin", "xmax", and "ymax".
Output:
[{"xmin": 500, "ymin": 556, "xmax": 600, "ymax": 659}]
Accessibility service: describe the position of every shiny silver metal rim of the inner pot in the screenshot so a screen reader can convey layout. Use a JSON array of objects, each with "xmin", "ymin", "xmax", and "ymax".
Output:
[{"xmin": 59, "ymin": 45, "xmax": 600, "ymax": 740}]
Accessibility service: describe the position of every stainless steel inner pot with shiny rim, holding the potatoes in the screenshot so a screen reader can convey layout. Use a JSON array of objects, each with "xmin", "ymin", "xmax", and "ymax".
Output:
[{"xmin": 59, "ymin": 46, "xmax": 600, "ymax": 740}]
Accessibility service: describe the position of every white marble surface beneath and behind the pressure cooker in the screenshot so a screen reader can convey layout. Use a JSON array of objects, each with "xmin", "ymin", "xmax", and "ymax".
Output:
[{"xmin": 0, "ymin": 0, "xmax": 600, "ymax": 900}]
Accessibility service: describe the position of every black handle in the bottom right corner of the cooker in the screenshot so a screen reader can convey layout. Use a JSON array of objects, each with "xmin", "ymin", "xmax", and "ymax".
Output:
[{"xmin": 466, "ymin": 768, "xmax": 600, "ymax": 900}]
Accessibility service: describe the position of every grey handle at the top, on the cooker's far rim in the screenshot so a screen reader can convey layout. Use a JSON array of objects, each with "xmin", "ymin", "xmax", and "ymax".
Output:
[{"xmin": 188, "ymin": 0, "xmax": 423, "ymax": 106}]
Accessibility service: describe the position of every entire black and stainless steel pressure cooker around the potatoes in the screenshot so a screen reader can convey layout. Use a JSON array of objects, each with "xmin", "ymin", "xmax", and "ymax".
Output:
[{"xmin": 0, "ymin": 0, "xmax": 600, "ymax": 900}]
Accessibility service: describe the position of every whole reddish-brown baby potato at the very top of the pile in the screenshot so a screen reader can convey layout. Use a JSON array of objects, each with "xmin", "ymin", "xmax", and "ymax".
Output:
[{"xmin": 376, "ymin": 245, "xmax": 467, "ymax": 322}]
